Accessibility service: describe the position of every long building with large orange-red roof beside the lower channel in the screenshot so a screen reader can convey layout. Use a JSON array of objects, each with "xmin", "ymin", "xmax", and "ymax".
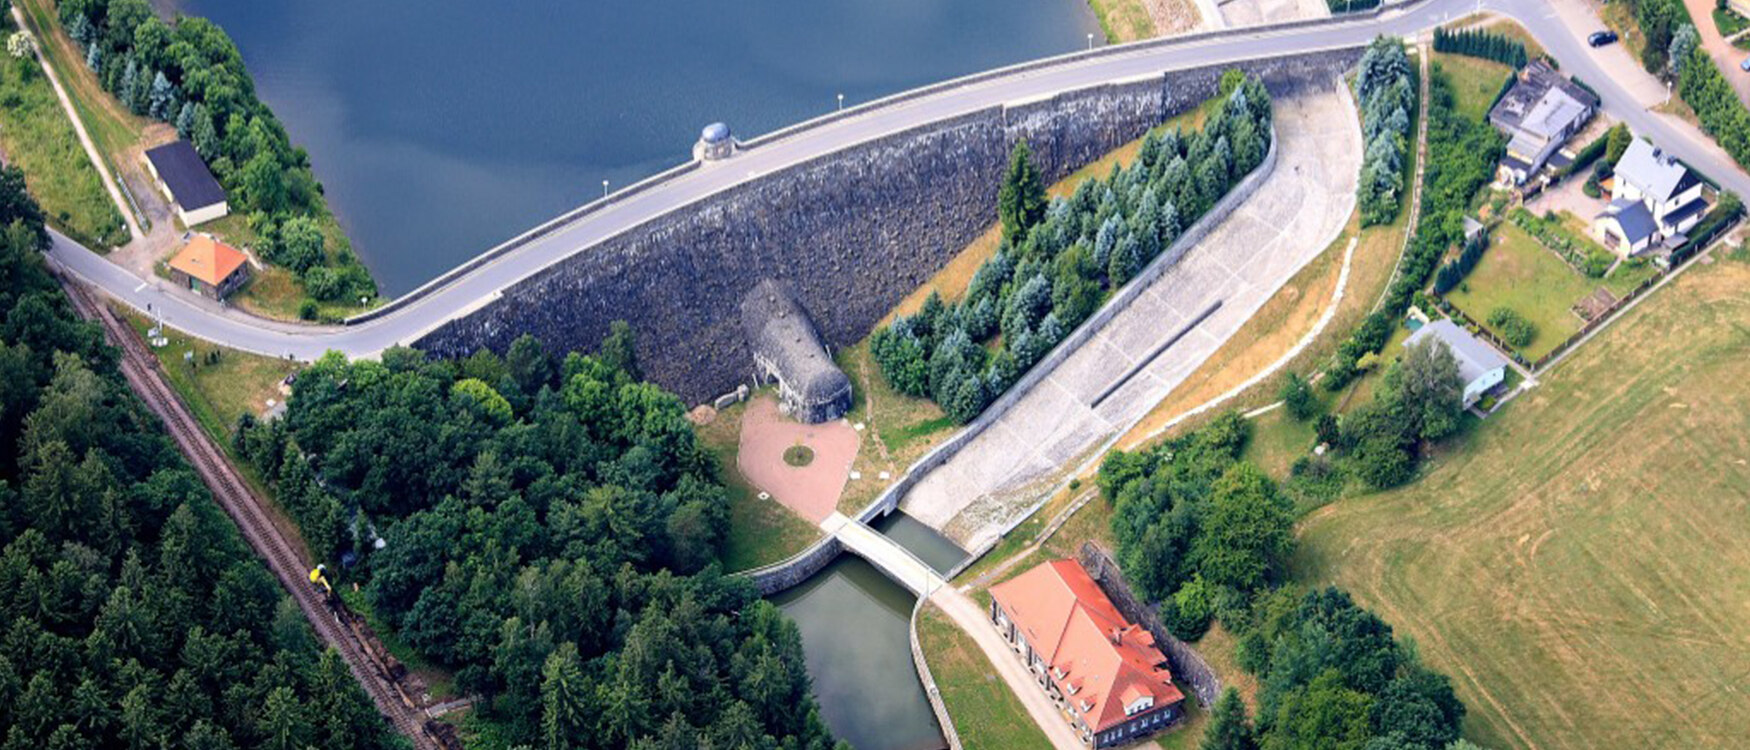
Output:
[{"xmin": 991, "ymin": 559, "xmax": 1185, "ymax": 748}]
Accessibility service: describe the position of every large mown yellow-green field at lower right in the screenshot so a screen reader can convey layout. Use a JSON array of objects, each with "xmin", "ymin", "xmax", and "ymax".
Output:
[{"xmin": 1293, "ymin": 253, "xmax": 1750, "ymax": 748}]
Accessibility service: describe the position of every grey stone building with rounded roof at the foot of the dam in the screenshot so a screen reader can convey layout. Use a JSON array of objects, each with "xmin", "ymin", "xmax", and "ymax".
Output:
[{"xmin": 742, "ymin": 280, "xmax": 851, "ymax": 423}]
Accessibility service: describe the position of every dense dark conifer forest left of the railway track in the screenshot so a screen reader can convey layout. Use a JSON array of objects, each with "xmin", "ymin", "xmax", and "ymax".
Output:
[{"xmin": 0, "ymin": 170, "xmax": 403, "ymax": 750}]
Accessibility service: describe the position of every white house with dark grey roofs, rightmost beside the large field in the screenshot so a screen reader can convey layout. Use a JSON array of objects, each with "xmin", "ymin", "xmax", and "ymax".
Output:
[{"xmin": 1593, "ymin": 138, "xmax": 1708, "ymax": 257}]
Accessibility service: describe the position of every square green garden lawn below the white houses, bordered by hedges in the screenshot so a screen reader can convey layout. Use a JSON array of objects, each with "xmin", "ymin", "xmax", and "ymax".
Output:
[{"xmin": 1446, "ymin": 222, "xmax": 1600, "ymax": 362}]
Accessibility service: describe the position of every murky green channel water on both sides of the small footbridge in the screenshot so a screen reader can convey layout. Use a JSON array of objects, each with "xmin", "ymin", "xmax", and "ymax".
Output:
[{"xmin": 772, "ymin": 512, "xmax": 966, "ymax": 750}]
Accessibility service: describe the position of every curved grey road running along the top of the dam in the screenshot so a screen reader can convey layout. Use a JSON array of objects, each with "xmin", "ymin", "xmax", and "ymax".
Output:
[{"xmin": 49, "ymin": 0, "xmax": 1750, "ymax": 360}]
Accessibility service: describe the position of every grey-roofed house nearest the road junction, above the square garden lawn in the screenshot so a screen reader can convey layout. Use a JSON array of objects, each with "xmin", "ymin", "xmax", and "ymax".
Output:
[{"xmin": 1489, "ymin": 59, "xmax": 1598, "ymax": 185}]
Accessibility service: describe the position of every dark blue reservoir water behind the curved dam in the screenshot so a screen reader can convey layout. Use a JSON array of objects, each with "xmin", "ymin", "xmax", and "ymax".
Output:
[{"xmin": 158, "ymin": 0, "xmax": 1099, "ymax": 295}]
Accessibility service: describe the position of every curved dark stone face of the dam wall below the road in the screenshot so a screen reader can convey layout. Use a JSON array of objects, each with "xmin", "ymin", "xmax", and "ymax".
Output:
[{"xmin": 417, "ymin": 47, "xmax": 1362, "ymax": 404}]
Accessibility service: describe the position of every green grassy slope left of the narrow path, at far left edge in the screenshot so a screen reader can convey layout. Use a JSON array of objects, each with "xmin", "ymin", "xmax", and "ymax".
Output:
[{"xmin": 0, "ymin": 51, "xmax": 128, "ymax": 252}]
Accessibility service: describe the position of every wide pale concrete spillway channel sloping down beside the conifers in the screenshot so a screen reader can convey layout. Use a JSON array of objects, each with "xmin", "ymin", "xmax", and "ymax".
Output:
[{"xmin": 901, "ymin": 86, "xmax": 1362, "ymax": 549}]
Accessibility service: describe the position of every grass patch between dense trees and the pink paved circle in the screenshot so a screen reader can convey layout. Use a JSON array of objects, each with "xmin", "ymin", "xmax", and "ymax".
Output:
[{"xmin": 697, "ymin": 402, "xmax": 821, "ymax": 572}]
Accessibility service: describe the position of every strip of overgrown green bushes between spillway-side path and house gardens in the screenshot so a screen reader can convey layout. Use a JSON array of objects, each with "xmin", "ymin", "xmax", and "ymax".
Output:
[{"xmin": 1320, "ymin": 63, "xmax": 1505, "ymax": 392}]
